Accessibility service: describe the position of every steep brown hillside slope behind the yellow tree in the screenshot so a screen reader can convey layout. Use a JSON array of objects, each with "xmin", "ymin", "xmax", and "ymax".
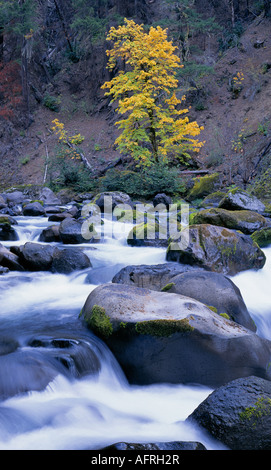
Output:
[{"xmin": 0, "ymin": 0, "xmax": 271, "ymax": 196}]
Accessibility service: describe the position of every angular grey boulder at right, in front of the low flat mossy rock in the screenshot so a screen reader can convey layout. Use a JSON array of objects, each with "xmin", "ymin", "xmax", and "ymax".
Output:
[{"xmin": 167, "ymin": 224, "xmax": 266, "ymax": 276}]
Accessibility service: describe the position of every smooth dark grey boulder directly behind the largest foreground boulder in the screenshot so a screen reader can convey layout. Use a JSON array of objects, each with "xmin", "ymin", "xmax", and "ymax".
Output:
[{"xmin": 112, "ymin": 263, "xmax": 256, "ymax": 331}]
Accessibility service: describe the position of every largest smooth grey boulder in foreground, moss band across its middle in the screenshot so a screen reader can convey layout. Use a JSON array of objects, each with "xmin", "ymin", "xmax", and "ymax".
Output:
[{"xmin": 81, "ymin": 284, "xmax": 271, "ymax": 387}]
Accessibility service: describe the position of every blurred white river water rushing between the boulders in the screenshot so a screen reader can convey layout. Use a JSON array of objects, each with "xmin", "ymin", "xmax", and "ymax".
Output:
[{"xmin": 0, "ymin": 211, "xmax": 271, "ymax": 450}]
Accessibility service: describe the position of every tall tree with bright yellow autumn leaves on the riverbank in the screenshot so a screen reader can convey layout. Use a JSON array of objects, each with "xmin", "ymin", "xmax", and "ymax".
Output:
[{"xmin": 102, "ymin": 19, "xmax": 203, "ymax": 165}]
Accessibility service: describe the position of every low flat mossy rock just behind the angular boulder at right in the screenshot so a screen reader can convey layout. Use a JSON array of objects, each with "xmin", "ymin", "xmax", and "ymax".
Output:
[{"xmin": 192, "ymin": 208, "xmax": 267, "ymax": 235}]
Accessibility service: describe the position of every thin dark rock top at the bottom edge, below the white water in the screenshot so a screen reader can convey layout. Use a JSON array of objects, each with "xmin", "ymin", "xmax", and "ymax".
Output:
[{"xmin": 101, "ymin": 441, "xmax": 207, "ymax": 451}]
